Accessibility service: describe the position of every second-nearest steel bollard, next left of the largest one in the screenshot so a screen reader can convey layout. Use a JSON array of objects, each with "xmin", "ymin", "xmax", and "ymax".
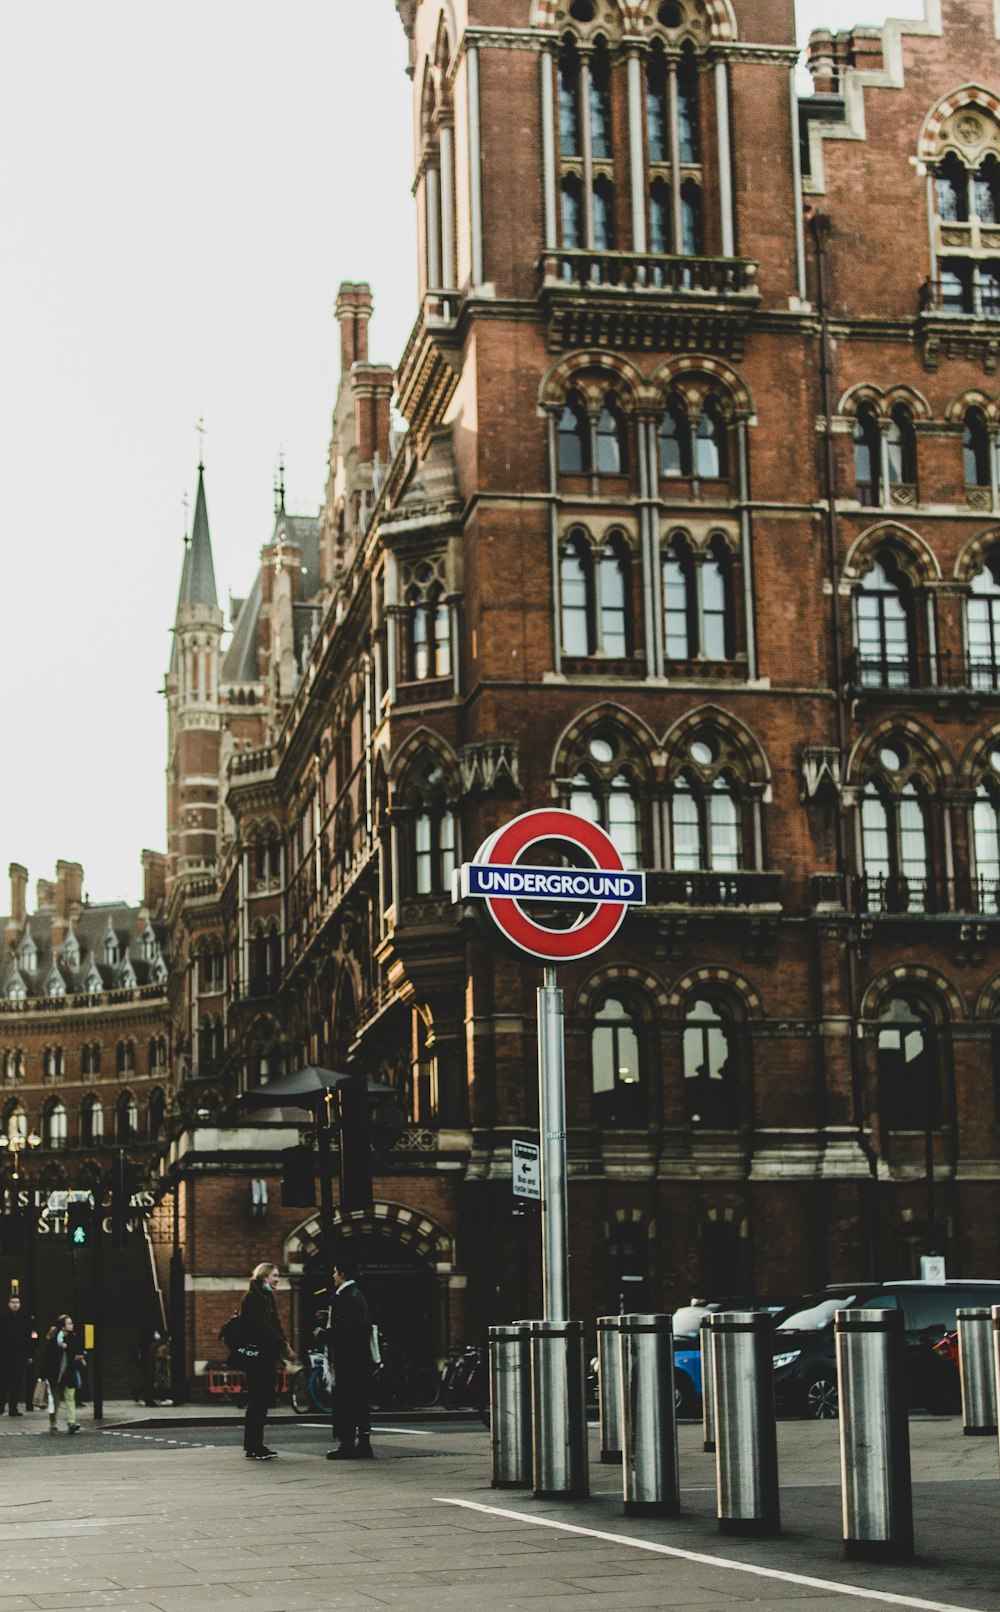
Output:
[{"xmin": 708, "ymin": 1311, "xmax": 781, "ymax": 1535}]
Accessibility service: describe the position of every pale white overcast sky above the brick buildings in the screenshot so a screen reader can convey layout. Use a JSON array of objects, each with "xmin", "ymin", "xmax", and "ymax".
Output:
[{"xmin": 0, "ymin": 0, "xmax": 923, "ymax": 912}]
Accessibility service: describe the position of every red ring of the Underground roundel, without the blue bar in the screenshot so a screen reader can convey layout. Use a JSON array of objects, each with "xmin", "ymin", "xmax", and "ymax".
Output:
[{"xmin": 476, "ymin": 806, "xmax": 626, "ymax": 962}]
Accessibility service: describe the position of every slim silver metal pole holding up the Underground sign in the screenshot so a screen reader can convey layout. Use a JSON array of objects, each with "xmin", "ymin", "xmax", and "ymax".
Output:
[{"xmin": 539, "ymin": 969, "xmax": 569, "ymax": 1322}]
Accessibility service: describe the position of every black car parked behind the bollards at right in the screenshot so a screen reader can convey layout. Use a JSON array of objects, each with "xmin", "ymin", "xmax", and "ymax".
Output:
[{"xmin": 774, "ymin": 1282, "xmax": 1000, "ymax": 1419}]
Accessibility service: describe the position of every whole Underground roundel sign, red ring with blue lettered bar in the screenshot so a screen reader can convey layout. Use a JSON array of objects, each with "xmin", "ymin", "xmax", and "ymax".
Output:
[{"xmin": 455, "ymin": 806, "xmax": 645, "ymax": 964}]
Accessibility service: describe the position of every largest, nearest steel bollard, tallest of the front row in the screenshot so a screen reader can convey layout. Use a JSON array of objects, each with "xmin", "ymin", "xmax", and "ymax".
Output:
[{"xmin": 834, "ymin": 1309, "xmax": 913, "ymax": 1562}]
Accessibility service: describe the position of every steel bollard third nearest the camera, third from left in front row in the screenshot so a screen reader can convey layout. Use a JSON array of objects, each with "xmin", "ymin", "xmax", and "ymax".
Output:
[{"xmin": 619, "ymin": 1315, "xmax": 681, "ymax": 1517}]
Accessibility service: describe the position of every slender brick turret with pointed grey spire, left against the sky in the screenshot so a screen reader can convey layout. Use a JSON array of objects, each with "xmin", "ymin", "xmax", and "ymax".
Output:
[{"xmin": 166, "ymin": 464, "xmax": 223, "ymax": 882}]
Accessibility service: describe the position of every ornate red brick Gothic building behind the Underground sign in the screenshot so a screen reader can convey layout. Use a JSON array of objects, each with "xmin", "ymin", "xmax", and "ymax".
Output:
[{"xmin": 168, "ymin": 0, "xmax": 1000, "ymax": 1386}]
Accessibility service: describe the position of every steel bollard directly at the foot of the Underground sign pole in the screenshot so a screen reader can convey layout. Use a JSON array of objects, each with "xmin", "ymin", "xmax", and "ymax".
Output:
[{"xmin": 531, "ymin": 1320, "xmax": 590, "ymax": 1499}]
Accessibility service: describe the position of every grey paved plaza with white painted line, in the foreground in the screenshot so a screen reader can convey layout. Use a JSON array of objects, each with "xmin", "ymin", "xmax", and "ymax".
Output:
[{"xmin": 0, "ymin": 1407, "xmax": 1000, "ymax": 1612}]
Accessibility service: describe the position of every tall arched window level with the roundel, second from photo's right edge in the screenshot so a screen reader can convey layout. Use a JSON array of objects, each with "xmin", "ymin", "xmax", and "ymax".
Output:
[{"xmin": 861, "ymin": 740, "xmax": 931, "ymax": 912}]
